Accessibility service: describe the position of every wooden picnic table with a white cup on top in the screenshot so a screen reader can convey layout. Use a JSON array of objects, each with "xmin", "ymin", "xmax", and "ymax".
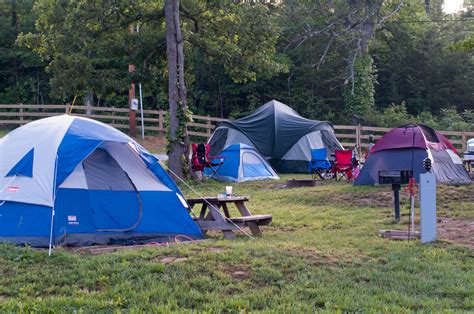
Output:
[{"xmin": 187, "ymin": 196, "xmax": 272, "ymax": 239}]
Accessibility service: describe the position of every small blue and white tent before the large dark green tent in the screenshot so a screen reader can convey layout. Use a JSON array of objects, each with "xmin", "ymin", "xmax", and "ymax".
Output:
[{"xmin": 205, "ymin": 144, "xmax": 279, "ymax": 182}]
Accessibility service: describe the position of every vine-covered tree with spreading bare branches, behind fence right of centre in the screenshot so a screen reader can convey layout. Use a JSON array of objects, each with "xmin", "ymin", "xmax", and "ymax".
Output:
[{"xmin": 287, "ymin": 0, "xmax": 403, "ymax": 122}]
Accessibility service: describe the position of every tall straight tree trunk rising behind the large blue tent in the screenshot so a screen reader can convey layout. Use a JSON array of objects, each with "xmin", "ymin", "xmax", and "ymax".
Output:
[{"xmin": 165, "ymin": 0, "xmax": 189, "ymax": 178}]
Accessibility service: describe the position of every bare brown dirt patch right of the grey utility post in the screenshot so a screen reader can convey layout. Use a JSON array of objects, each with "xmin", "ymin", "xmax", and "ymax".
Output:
[{"xmin": 437, "ymin": 217, "xmax": 474, "ymax": 249}]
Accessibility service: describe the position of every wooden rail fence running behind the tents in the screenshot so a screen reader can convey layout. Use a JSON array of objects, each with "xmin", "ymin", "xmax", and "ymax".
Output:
[{"xmin": 0, "ymin": 104, "xmax": 474, "ymax": 152}]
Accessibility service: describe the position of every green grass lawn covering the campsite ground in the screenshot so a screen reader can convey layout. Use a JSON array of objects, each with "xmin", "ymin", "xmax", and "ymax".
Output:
[{"xmin": 0, "ymin": 175, "xmax": 474, "ymax": 312}]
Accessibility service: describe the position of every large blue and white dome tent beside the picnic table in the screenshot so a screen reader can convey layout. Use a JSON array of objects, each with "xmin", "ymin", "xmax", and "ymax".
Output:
[{"xmin": 0, "ymin": 115, "xmax": 202, "ymax": 247}]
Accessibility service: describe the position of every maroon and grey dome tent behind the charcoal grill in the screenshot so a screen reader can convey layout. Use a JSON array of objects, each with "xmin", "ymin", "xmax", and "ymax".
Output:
[{"xmin": 354, "ymin": 124, "xmax": 471, "ymax": 185}]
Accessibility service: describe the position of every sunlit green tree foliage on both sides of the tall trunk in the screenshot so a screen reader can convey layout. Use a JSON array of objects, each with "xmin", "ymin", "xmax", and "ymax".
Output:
[{"xmin": 15, "ymin": 0, "xmax": 286, "ymax": 107}]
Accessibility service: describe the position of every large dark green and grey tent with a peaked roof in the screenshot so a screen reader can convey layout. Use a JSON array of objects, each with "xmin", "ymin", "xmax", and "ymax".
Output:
[{"xmin": 209, "ymin": 100, "xmax": 342, "ymax": 172}]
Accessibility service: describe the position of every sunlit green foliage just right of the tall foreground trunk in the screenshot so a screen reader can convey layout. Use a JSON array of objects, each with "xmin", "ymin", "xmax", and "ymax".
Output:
[{"xmin": 184, "ymin": 1, "xmax": 288, "ymax": 83}]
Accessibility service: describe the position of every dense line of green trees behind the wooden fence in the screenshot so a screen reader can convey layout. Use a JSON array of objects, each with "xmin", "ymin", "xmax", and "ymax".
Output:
[{"xmin": 0, "ymin": 0, "xmax": 474, "ymax": 129}]
